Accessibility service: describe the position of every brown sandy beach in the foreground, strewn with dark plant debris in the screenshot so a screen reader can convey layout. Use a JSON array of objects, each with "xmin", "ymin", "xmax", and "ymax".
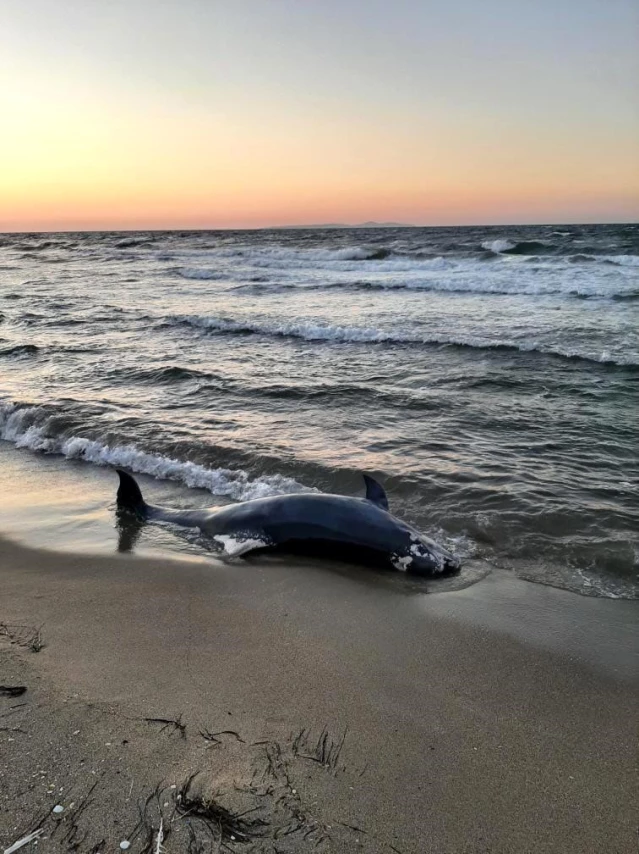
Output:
[{"xmin": 0, "ymin": 541, "xmax": 639, "ymax": 854}]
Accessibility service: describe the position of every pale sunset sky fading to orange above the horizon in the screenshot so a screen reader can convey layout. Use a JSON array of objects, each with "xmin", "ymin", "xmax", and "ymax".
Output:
[{"xmin": 0, "ymin": 0, "xmax": 639, "ymax": 231}]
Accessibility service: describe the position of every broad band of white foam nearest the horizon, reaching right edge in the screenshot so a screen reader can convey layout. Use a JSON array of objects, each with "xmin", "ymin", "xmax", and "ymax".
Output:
[{"xmin": 161, "ymin": 246, "xmax": 639, "ymax": 299}]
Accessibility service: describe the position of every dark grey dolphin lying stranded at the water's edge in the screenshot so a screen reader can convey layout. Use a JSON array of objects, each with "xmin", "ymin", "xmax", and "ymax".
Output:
[{"xmin": 117, "ymin": 469, "xmax": 461, "ymax": 576}]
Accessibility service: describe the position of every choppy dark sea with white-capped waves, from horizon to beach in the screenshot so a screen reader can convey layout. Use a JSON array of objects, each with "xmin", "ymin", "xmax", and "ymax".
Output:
[{"xmin": 0, "ymin": 224, "xmax": 639, "ymax": 598}]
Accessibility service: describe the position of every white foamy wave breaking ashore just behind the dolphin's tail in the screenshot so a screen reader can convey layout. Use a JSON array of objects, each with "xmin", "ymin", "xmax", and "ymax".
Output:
[{"xmin": 0, "ymin": 402, "xmax": 314, "ymax": 501}]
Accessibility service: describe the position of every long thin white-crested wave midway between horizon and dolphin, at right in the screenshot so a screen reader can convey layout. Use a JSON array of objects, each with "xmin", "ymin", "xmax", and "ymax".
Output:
[{"xmin": 162, "ymin": 315, "xmax": 639, "ymax": 367}]
